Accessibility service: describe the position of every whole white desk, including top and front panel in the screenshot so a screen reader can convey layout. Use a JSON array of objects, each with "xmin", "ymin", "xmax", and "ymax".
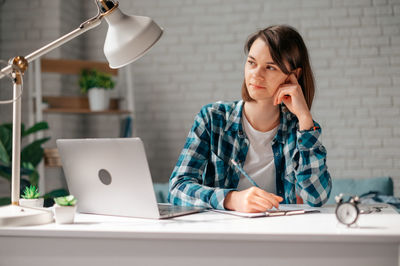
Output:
[{"xmin": 0, "ymin": 206, "xmax": 400, "ymax": 266}]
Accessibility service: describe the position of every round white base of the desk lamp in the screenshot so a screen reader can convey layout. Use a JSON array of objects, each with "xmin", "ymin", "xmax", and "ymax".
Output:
[{"xmin": 0, "ymin": 205, "xmax": 53, "ymax": 226}]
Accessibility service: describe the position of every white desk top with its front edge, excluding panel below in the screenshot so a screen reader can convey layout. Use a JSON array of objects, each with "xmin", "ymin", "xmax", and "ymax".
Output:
[{"xmin": 0, "ymin": 207, "xmax": 400, "ymax": 244}]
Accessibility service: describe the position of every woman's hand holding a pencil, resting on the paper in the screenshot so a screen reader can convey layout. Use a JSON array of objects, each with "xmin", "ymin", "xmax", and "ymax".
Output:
[{"xmin": 224, "ymin": 187, "xmax": 283, "ymax": 212}]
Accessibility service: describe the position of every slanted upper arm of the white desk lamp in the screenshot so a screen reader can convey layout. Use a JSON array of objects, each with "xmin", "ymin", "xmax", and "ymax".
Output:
[{"xmin": 0, "ymin": 14, "xmax": 103, "ymax": 79}]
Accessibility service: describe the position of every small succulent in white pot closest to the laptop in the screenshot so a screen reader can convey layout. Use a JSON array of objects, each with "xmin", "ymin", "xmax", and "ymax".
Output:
[{"xmin": 54, "ymin": 195, "xmax": 77, "ymax": 224}]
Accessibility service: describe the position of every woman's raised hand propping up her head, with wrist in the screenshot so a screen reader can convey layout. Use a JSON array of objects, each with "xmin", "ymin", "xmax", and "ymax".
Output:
[{"xmin": 274, "ymin": 73, "xmax": 314, "ymax": 130}]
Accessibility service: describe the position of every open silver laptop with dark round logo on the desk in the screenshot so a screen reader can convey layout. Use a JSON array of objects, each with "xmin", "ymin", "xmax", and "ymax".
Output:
[{"xmin": 56, "ymin": 138, "xmax": 204, "ymax": 219}]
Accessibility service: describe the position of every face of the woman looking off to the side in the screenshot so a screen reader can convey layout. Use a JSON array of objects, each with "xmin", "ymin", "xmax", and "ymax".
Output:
[{"xmin": 244, "ymin": 38, "xmax": 288, "ymax": 101}]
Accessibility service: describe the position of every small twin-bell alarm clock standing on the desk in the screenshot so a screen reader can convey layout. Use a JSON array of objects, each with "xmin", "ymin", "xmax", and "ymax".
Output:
[{"xmin": 335, "ymin": 193, "xmax": 360, "ymax": 226}]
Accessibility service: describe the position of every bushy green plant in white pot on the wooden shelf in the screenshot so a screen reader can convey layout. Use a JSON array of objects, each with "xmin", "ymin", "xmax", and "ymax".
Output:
[{"xmin": 79, "ymin": 69, "xmax": 115, "ymax": 111}]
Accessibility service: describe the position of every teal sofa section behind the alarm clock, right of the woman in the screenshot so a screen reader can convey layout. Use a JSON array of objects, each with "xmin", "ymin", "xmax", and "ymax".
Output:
[{"xmin": 326, "ymin": 177, "xmax": 393, "ymax": 204}]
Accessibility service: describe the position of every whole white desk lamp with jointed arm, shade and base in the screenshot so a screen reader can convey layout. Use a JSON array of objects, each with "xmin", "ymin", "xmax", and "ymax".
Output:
[{"xmin": 0, "ymin": 0, "xmax": 163, "ymax": 226}]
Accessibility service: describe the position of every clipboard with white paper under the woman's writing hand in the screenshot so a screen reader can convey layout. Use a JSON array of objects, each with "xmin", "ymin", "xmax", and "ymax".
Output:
[{"xmin": 213, "ymin": 204, "xmax": 320, "ymax": 218}]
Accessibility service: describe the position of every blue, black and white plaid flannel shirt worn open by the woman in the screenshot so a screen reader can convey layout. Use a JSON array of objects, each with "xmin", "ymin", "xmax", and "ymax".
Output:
[{"xmin": 168, "ymin": 101, "xmax": 332, "ymax": 209}]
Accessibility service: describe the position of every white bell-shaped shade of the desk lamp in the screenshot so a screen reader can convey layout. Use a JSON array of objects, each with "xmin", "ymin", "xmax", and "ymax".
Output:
[{"xmin": 104, "ymin": 8, "xmax": 163, "ymax": 68}]
